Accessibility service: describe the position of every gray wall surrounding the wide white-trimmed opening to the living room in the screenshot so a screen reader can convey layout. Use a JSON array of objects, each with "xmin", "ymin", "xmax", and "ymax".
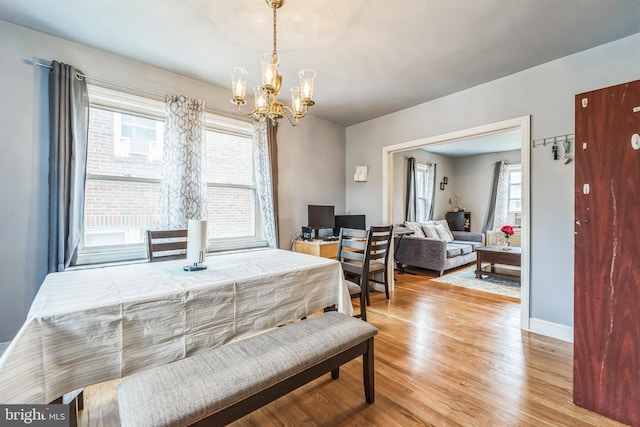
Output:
[{"xmin": 346, "ymin": 34, "xmax": 640, "ymax": 326}]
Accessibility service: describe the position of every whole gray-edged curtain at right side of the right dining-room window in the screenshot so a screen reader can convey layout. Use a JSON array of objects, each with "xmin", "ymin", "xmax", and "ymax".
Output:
[{"xmin": 253, "ymin": 120, "xmax": 278, "ymax": 248}]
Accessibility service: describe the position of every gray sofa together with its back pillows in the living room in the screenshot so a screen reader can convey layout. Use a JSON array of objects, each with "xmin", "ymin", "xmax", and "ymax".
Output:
[{"xmin": 394, "ymin": 220, "xmax": 484, "ymax": 276}]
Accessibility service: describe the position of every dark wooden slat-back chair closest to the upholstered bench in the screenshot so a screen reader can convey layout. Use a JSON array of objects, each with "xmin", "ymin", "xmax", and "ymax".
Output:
[{"xmin": 337, "ymin": 228, "xmax": 371, "ymax": 321}]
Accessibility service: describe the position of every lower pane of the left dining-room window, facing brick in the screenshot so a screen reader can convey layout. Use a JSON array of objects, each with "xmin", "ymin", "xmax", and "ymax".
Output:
[{"xmin": 85, "ymin": 179, "xmax": 160, "ymax": 247}]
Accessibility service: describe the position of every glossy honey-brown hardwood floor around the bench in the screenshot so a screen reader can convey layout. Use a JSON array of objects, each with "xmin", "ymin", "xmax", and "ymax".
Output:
[{"xmin": 80, "ymin": 274, "xmax": 622, "ymax": 427}]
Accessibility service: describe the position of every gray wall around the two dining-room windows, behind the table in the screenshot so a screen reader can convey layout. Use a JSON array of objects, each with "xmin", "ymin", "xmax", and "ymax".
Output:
[{"xmin": 0, "ymin": 21, "xmax": 346, "ymax": 342}]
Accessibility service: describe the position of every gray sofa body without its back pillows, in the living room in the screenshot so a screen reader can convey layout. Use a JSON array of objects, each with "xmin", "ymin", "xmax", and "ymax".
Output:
[{"xmin": 394, "ymin": 231, "xmax": 484, "ymax": 276}]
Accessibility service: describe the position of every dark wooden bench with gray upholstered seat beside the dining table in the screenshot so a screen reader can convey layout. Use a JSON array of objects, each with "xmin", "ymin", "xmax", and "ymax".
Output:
[{"xmin": 118, "ymin": 312, "xmax": 378, "ymax": 427}]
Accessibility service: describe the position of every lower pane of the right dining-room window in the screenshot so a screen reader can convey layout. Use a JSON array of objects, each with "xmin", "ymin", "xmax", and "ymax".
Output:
[{"xmin": 207, "ymin": 187, "xmax": 256, "ymax": 239}]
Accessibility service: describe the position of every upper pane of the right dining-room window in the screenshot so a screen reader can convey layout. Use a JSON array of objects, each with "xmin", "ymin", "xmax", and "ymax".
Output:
[{"xmin": 207, "ymin": 130, "xmax": 253, "ymax": 185}]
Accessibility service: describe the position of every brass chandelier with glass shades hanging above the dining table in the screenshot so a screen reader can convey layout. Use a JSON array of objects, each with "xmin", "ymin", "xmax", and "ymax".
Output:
[{"xmin": 231, "ymin": 0, "xmax": 316, "ymax": 126}]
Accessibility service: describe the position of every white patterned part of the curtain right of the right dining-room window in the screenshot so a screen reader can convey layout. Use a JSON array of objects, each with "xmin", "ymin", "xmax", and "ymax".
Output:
[{"xmin": 253, "ymin": 120, "xmax": 278, "ymax": 248}]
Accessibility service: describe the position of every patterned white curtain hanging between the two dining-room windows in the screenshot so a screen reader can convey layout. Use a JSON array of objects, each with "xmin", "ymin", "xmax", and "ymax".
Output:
[{"xmin": 160, "ymin": 95, "xmax": 207, "ymax": 229}]
